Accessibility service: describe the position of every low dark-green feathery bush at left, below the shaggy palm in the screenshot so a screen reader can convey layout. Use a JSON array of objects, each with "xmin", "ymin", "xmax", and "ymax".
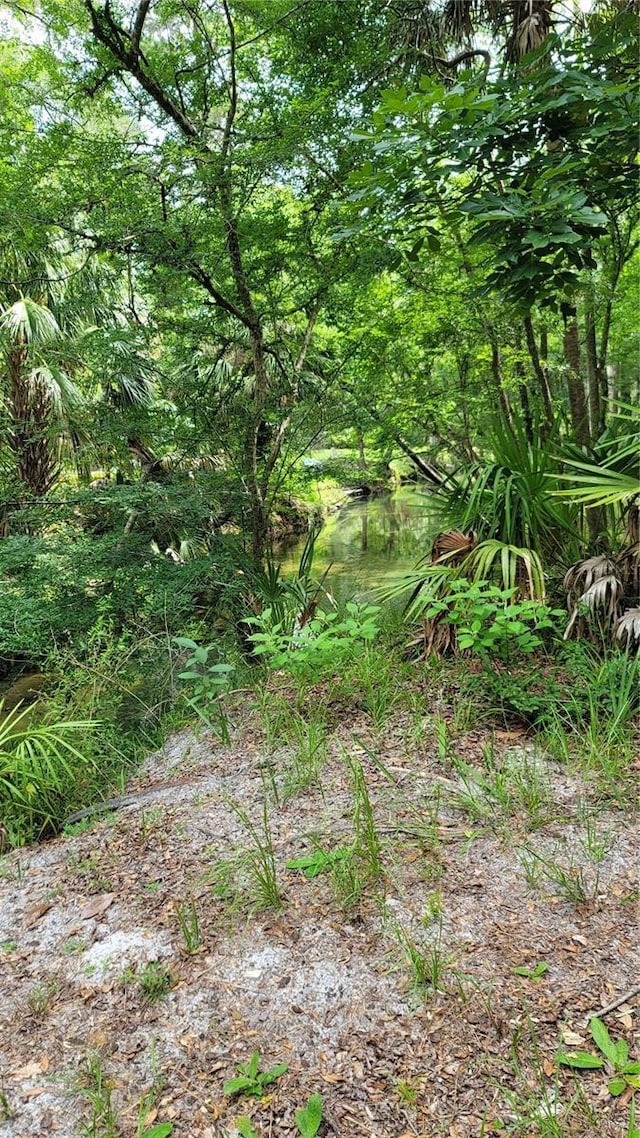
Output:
[{"xmin": 0, "ymin": 530, "xmax": 245, "ymax": 671}]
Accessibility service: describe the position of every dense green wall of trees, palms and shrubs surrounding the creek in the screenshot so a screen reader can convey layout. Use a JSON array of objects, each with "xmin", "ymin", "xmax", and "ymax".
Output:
[{"xmin": 0, "ymin": 0, "xmax": 640, "ymax": 840}]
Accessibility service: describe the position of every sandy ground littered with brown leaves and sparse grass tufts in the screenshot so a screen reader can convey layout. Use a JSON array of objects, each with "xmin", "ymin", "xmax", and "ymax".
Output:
[{"xmin": 0, "ymin": 677, "xmax": 640, "ymax": 1138}]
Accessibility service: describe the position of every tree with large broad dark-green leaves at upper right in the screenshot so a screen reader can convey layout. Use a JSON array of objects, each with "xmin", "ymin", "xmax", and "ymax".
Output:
[{"xmin": 353, "ymin": 6, "xmax": 638, "ymax": 444}]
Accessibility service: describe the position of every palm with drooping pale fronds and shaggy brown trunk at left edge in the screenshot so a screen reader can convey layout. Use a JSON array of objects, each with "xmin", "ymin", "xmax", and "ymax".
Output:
[{"xmin": 0, "ymin": 240, "xmax": 153, "ymax": 500}]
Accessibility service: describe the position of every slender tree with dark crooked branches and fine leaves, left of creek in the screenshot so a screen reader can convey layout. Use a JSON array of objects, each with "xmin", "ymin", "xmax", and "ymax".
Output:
[{"xmin": 8, "ymin": 0, "xmax": 389, "ymax": 556}]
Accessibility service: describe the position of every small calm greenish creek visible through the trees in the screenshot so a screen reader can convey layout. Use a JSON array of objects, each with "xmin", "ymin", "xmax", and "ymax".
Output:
[{"xmin": 280, "ymin": 485, "xmax": 438, "ymax": 603}]
